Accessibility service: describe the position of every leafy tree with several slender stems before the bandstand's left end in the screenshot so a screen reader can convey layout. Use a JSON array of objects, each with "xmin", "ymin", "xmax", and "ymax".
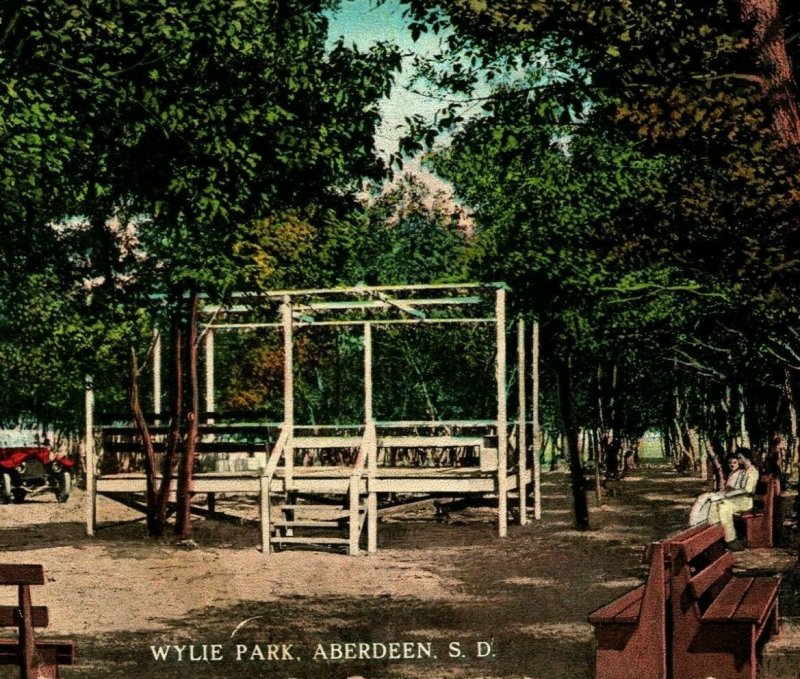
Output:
[{"xmin": 2, "ymin": 0, "xmax": 399, "ymax": 537}]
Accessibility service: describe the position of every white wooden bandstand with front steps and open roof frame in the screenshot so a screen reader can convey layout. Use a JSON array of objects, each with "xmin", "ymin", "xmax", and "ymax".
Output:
[{"xmin": 86, "ymin": 284, "xmax": 540, "ymax": 555}]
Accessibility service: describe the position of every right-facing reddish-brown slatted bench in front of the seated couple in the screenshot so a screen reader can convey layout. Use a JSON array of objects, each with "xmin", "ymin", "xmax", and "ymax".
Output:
[{"xmin": 666, "ymin": 524, "xmax": 780, "ymax": 679}]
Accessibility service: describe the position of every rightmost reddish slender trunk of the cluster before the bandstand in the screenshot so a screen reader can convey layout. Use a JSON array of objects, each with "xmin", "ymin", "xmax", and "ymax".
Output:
[{"xmin": 175, "ymin": 293, "xmax": 200, "ymax": 540}]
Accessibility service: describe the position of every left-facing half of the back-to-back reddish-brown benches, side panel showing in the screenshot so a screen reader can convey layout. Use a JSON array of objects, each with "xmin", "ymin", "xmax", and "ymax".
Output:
[{"xmin": 589, "ymin": 527, "xmax": 703, "ymax": 679}]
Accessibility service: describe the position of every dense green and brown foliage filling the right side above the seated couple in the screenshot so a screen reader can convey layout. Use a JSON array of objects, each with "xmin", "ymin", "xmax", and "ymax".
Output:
[{"xmin": 386, "ymin": 0, "xmax": 800, "ymax": 452}]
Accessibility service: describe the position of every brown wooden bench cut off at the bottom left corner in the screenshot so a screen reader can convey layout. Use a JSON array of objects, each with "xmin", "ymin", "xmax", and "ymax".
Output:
[{"xmin": 0, "ymin": 564, "xmax": 75, "ymax": 679}]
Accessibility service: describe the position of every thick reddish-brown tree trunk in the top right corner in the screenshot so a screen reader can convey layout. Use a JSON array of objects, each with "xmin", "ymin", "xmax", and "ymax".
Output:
[{"xmin": 740, "ymin": 0, "xmax": 800, "ymax": 159}]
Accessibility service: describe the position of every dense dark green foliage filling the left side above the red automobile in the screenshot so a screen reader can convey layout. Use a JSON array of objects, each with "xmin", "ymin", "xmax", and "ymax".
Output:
[{"xmin": 0, "ymin": 0, "xmax": 400, "ymax": 430}]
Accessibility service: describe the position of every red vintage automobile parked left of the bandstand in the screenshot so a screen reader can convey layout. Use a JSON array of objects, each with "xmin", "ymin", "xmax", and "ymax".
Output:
[{"xmin": 0, "ymin": 432, "xmax": 75, "ymax": 504}]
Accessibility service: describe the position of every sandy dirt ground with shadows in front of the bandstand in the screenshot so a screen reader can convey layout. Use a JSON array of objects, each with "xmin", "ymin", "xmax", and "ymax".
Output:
[{"xmin": 0, "ymin": 468, "xmax": 797, "ymax": 679}]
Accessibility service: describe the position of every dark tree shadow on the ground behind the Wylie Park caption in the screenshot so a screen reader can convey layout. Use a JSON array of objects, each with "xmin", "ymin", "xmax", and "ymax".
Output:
[{"xmin": 63, "ymin": 596, "xmax": 593, "ymax": 679}]
